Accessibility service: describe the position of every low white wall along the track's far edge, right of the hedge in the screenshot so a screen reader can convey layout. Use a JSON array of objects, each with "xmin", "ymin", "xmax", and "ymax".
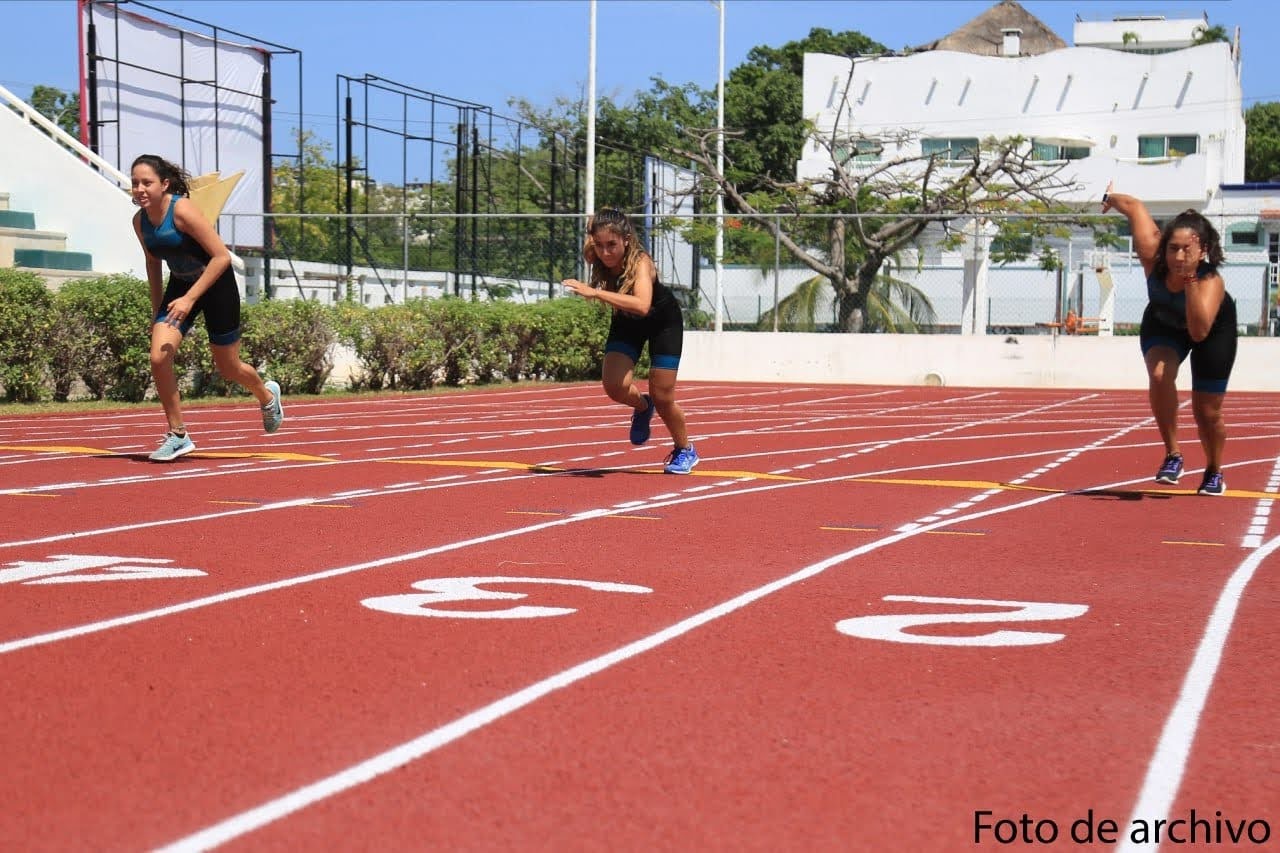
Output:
[{"xmin": 680, "ymin": 332, "xmax": 1280, "ymax": 391}]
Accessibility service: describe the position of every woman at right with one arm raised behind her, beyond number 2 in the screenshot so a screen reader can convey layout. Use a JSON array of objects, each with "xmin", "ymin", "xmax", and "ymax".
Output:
[{"xmin": 1102, "ymin": 186, "xmax": 1236, "ymax": 494}]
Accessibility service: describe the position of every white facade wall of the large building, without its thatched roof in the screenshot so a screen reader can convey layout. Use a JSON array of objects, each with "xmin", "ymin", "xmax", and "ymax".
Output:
[{"xmin": 797, "ymin": 42, "xmax": 1244, "ymax": 211}]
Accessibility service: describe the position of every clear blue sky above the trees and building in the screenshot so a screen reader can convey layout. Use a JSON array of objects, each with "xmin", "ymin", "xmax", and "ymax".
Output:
[{"xmin": 0, "ymin": 0, "xmax": 1280, "ymax": 174}]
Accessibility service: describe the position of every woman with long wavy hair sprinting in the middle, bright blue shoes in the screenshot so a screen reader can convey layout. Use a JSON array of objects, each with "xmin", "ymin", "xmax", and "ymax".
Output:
[{"xmin": 563, "ymin": 207, "xmax": 698, "ymax": 474}]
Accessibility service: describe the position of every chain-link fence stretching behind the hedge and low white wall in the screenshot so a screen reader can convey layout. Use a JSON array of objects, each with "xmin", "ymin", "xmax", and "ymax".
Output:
[{"xmin": 220, "ymin": 213, "xmax": 1277, "ymax": 336}]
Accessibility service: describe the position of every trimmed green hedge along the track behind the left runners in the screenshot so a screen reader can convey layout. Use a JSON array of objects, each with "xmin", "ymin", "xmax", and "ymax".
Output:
[{"xmin": 0, "ymin": 269, "xmax": 614, "ymax": 402}]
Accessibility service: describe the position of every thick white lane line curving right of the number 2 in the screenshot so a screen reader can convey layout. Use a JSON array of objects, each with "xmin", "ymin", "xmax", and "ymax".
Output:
[{"xmin": 1116, "ymin": 537, "xmax": 1280, "ymax": 853}]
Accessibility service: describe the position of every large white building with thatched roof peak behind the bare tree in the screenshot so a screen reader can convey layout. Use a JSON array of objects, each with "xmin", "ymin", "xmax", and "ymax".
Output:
[{"xmin": 796, "ymin": 0, "xmax": 1244, "ymax": 214}]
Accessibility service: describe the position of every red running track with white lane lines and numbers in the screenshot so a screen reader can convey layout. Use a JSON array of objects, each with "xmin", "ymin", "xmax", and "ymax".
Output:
[{"xmin": 0, "ymin": 383, "xmax": 1280, "ymax": 850}]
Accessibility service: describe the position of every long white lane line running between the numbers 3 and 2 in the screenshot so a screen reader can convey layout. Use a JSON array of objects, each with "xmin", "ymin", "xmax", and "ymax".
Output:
[{"xmin": 152, "ymin": 466, "xmax": 1146, "ymax": 853}]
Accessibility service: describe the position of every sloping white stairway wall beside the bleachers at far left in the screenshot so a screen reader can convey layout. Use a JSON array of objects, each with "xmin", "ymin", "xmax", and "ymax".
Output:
[{"xmin": 0, "ymin": 106, "xmax": 146, "ymax": 278}]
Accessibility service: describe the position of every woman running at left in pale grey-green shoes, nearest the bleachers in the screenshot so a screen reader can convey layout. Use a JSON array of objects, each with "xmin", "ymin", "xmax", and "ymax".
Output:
[{"xmin": 132, "ymin": 154, "xmax": 284, "ymax": 462}]
